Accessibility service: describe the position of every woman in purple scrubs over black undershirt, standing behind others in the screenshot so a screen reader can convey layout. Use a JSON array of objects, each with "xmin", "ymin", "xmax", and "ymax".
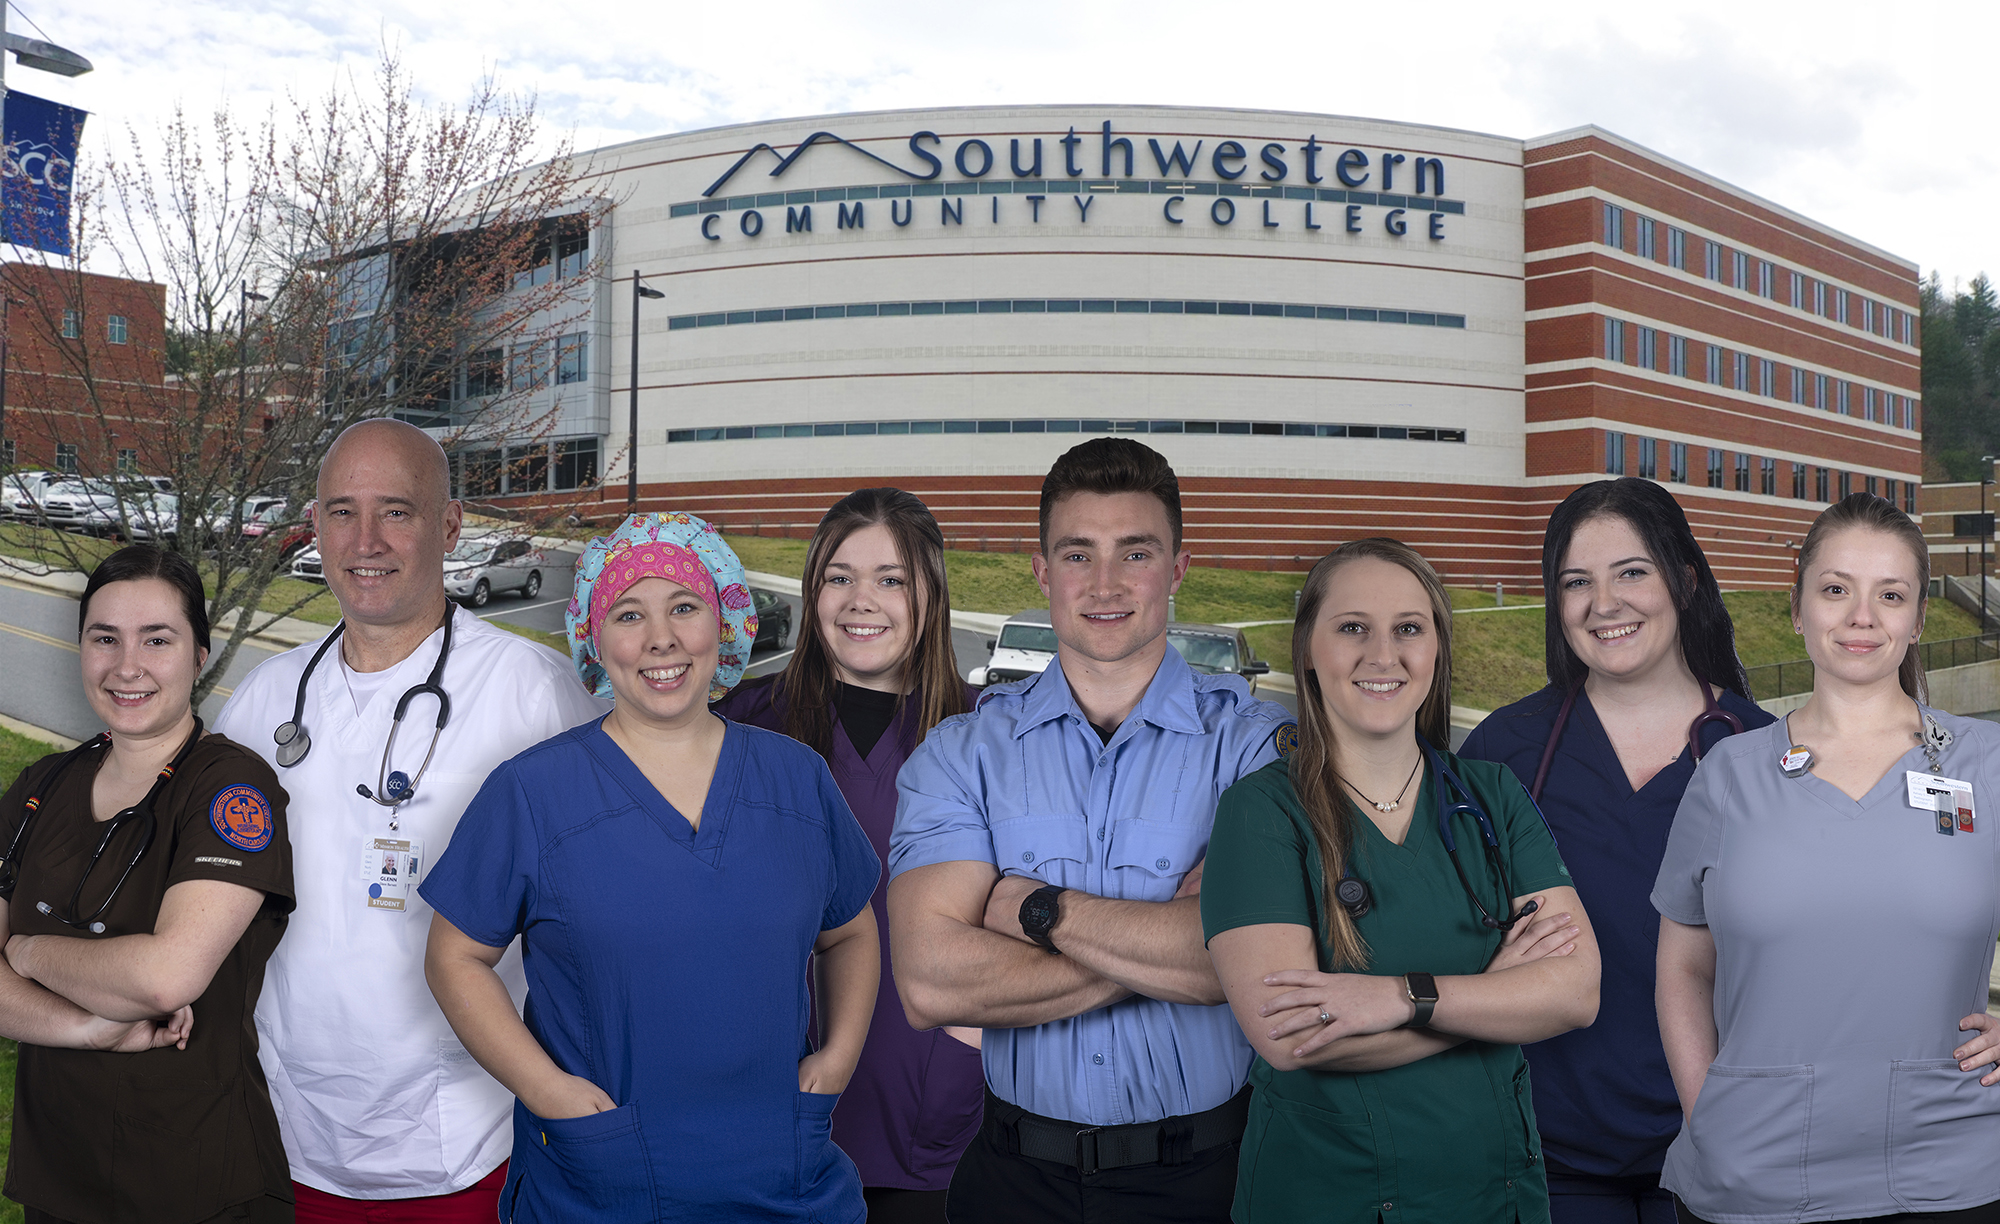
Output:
[{"xmin": 714, "ymin": 488, "xmax": 984, "ymax": 1224}]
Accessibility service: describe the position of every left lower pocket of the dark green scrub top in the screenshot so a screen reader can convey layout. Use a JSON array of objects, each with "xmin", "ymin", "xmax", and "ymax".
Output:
[{"xmin": 1230, "ymin": 1090, "xmax": 1400, "ymax": 1224}]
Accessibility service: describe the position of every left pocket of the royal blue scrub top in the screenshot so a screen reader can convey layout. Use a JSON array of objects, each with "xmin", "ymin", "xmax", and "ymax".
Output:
[{"xmin": 510, "ymin": 1104, "xmax": 658, "ymax": 1224}]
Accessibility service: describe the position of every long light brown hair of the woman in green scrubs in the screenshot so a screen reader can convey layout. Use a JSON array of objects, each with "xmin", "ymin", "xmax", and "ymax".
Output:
[{"xmin": 1290, "ymin": 536, "xmax": 1452, "ymax": 970}]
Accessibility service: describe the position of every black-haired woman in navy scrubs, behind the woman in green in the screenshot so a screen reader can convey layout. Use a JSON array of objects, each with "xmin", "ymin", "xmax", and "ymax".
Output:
[{"xmin": 1460, "ymin": 478, "xmax": 1772, "ymax": 1224}]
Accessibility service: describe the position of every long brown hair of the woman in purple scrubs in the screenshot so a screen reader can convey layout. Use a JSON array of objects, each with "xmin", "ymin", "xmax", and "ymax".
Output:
[{"xmin": 778, "ymin": 488, "xmax": 966, "ymax": 760}]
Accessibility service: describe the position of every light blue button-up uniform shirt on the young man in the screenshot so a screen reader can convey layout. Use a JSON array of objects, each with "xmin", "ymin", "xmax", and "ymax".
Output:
[{"xmin": 890, "ymin": 650, "xmax": 1292, "ymax": 1126}]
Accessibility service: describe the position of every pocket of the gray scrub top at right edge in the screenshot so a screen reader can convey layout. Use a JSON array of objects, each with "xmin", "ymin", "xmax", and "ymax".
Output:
[{"xmin": 1888, "ymin": 1058, "xmax": 2000, "ymax": 1212}]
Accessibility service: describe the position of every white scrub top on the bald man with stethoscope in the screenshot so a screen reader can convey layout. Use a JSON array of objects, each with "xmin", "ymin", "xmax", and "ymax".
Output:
[{"xmin": 214, "ymin": 606, "xmax": 610, "ymax": 1198}]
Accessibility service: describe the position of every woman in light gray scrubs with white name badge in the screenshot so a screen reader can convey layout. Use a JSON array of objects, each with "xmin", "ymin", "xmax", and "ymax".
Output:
[{"xmin": 1652, "ymin": 494, "xmax": 2000, "ymax": 1224}]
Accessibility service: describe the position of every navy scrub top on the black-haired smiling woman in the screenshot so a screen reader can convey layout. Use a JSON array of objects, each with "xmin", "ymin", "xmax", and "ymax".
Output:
[{"xmin": 1460, "ymin": 688, "xmax": 1774, "ymax": 1178}]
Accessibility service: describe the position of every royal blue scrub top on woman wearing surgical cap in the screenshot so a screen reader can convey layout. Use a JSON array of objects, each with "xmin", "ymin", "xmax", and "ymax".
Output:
[{"xmin": 420, "ymin": 722, "xmax": 880, "ymax": 1224}]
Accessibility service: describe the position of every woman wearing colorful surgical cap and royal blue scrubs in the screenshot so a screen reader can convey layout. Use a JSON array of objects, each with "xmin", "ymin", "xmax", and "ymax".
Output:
[{"xmin": 422, "ymin": 514, "xmax": 880, "ymax": 1224}]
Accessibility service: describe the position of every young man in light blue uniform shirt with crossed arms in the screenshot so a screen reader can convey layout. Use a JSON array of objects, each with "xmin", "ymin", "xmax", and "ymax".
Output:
[{"xmin": 888, "ymin": 438, "xmax": 1292, "ymax": 1224}]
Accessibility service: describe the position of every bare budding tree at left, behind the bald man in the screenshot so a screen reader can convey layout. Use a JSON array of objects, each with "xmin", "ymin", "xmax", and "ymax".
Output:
[{"xmin": 0, "ymin": 52, "xmax": 608, "ymax": 700}]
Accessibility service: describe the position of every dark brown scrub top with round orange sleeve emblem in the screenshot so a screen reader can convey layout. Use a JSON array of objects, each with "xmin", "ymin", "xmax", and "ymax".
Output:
[{"xmin": 0, "ymin": 736, "xmax": 292, "ymax": 1224}]
